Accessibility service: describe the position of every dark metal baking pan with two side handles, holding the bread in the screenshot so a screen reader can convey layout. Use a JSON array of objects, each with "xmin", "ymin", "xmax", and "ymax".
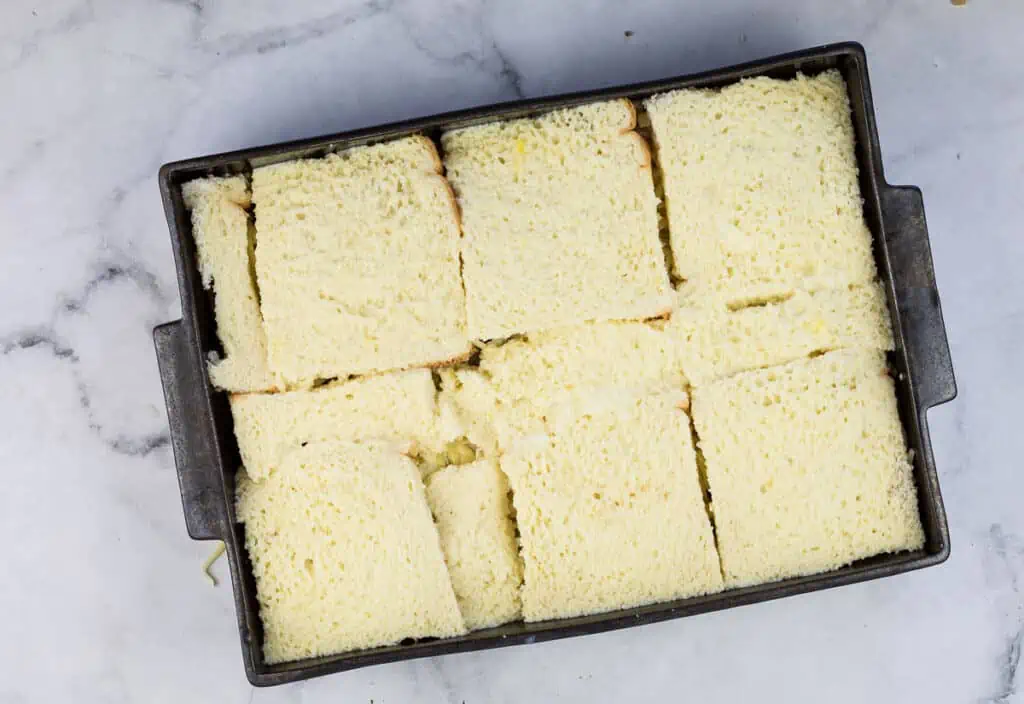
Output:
[{"xmin": 154, "ymin": 43, "xmax": 956, "ymax": 686}]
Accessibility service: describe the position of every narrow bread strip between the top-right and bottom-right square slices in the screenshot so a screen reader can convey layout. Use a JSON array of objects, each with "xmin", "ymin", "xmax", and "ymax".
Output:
[{"xmin": 666, "ymin": 282, "xmax": 894, "ymax": 386}]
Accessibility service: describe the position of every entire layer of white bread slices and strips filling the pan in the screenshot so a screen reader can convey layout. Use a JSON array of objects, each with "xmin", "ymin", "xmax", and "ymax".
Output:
[{"xmin": 207, "ymin": 71, "xmax": 925, "ymax": 663}]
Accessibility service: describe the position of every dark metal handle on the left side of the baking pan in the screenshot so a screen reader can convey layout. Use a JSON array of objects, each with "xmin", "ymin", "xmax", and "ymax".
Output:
[{"xmin": 153, "ymin": 320, "xmax": 227, "ymax": 540}]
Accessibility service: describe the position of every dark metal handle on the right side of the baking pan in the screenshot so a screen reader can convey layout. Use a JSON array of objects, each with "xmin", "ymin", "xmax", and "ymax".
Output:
[{"xmin": 882, "ymin": 186, "xmax": 956, "ymax": 410}]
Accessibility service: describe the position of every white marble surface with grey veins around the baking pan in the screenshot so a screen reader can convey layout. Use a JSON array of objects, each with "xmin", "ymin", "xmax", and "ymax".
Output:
[{"xmin": 0, "ymin": 0, "xmax": 1024, "ymax": 704}]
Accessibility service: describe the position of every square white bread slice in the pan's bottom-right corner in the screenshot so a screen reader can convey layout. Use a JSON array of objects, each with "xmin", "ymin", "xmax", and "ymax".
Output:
[{"xmin": 692, "ymin": 350, "xmax": 924, "ymax": 587}]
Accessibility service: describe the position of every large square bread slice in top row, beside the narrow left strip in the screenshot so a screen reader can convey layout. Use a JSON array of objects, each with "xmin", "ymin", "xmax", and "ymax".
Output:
[{"xmin": 253, "ymin": 136, "xmax": 470, "ymax": 384}]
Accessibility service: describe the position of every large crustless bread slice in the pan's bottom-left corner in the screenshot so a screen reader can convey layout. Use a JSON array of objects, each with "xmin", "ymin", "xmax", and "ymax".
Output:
[{"xmin": 237, "ymin": 442, "xmax": 466, "ymax": 663}]
